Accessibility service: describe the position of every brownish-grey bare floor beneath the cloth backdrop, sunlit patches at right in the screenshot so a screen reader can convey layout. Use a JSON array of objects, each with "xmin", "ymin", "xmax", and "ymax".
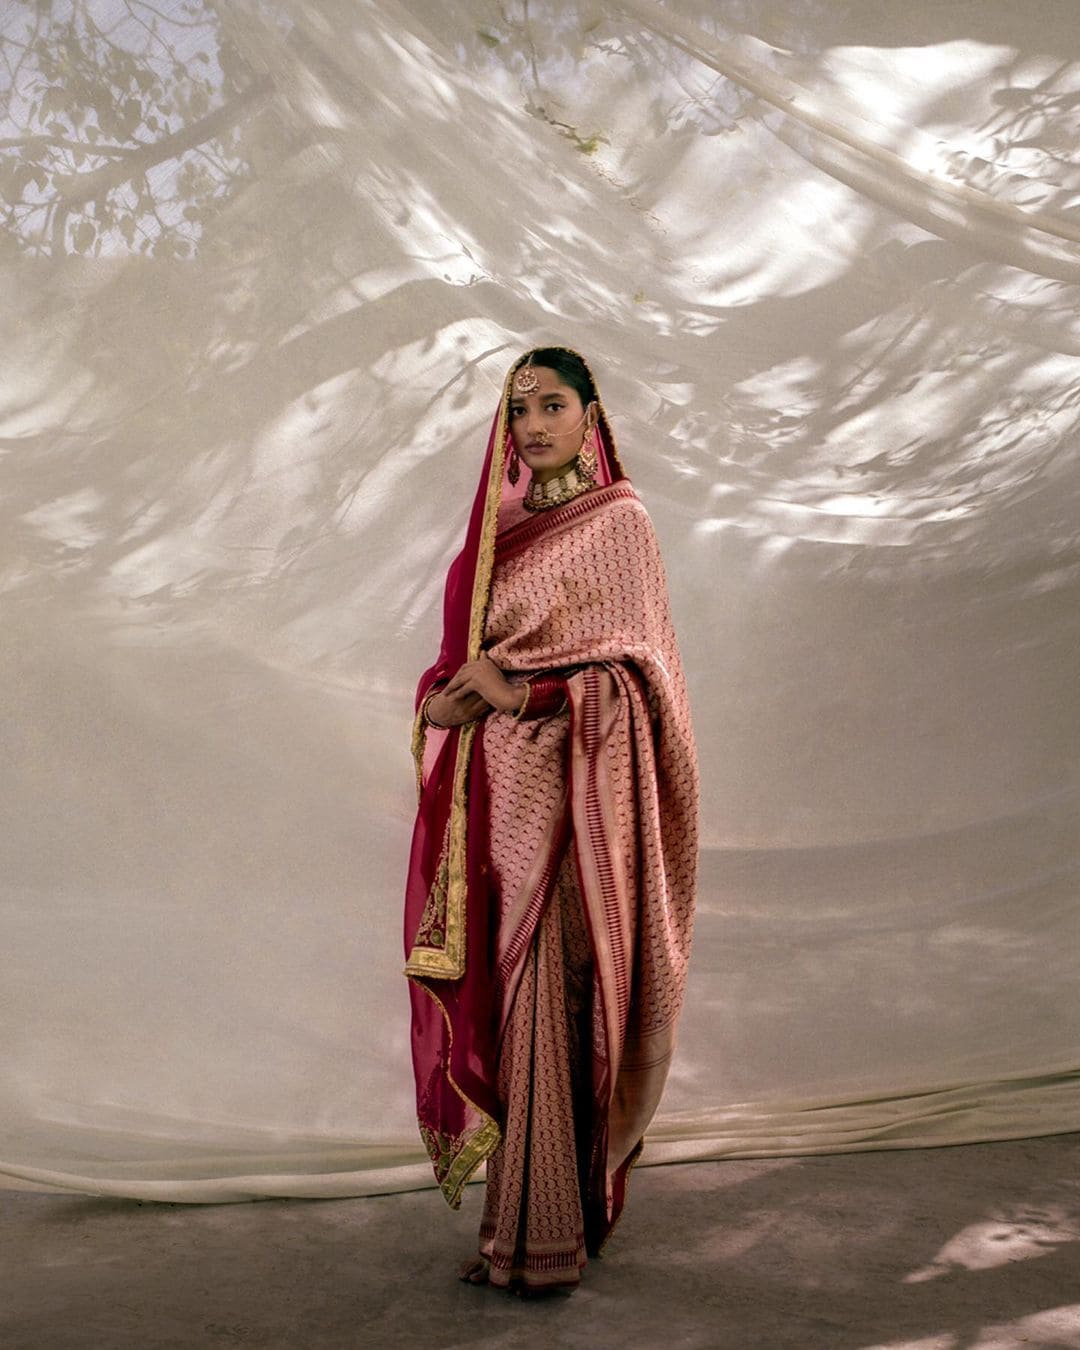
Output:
[{"xmin": 0, "ymin": 1134, "xmax": 1080, "ymax": 1350}]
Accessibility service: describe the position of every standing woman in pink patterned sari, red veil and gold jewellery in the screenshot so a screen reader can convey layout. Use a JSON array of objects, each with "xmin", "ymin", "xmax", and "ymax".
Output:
[{"xmin": 405, "ymin": 347, "xmax": 698, "ymax": 1292}]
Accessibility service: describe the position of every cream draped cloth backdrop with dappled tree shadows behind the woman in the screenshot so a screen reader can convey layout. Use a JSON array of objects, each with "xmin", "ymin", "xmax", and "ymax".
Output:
[{"xmin": 0, "ymin": 0, "xmax": 1080, "ymax": 1202}]
